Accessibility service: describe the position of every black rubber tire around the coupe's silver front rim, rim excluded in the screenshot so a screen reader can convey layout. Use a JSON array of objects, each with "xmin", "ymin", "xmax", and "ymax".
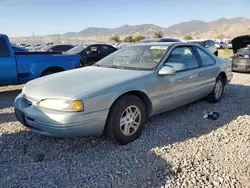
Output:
[{"xmin": 105, "ymin": 95, "xmax": 146, "ymax": 145}]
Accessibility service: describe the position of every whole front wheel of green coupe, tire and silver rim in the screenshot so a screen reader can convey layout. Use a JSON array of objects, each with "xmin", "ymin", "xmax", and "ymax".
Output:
[{"xmin": 105, "ymin": 95, "xmax": 146, "ymax": 145}]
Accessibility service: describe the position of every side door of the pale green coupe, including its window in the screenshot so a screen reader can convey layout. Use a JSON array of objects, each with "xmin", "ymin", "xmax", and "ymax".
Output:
[{"xmin": 155, "ymin": 46, "xmax": 203, "ymax": 113}]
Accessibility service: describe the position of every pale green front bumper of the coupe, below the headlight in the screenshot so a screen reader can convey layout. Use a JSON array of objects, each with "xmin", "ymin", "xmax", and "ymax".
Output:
[{"xmin": 15, "ymin": 94, "xmax": 109, "ymax": 137}]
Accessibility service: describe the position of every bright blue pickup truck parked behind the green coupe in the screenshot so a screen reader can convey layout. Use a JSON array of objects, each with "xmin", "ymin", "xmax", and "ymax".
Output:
[{"xmin": 0, "ymin": 34, "xmax": 80, "ymax": 86}]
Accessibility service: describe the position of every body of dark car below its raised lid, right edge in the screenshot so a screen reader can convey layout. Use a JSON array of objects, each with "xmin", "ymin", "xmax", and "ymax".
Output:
[{"xmin": 231, "ymin": 45, "xmax": 250, "ymax": 72}]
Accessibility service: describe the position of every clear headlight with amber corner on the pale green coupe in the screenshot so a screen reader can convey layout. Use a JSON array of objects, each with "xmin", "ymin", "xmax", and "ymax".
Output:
[{"xmin": 39, "ymin": 99, "xmax": 84, "ymax": 112}]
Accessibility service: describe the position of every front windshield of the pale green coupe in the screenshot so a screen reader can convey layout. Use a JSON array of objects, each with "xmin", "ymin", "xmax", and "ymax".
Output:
[{"xmin": 95, "ymin": 45, "xmax": 168, "ymax": 70}]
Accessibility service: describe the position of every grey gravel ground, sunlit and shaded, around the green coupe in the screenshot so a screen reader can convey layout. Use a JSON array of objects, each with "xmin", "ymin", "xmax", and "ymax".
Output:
[{"xmin": 0, "ymin": 73, "xmax": 250, "ymax": 188}]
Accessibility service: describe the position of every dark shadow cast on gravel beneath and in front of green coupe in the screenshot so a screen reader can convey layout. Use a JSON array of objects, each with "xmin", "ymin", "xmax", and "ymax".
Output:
[{"xmin": 0, "ymin": 84, "xmax": 250, "ymax": 188}]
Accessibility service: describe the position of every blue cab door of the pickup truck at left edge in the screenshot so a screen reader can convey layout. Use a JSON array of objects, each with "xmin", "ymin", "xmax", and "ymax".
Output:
[{"xmin": 0, "ymin": 38, "xmax": 18, "ymax": 85}]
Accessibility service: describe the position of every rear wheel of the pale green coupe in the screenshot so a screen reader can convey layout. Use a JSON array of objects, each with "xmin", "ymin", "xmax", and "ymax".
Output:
[{"xmin": 207, "ymin": 76, "xmax": 225, "ymax": 102}]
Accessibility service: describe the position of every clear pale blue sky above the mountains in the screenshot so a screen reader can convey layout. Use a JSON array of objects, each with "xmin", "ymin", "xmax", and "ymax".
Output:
[{"xmin": 0, "ymin": 0, "xmax": 250, "ymax": 36}]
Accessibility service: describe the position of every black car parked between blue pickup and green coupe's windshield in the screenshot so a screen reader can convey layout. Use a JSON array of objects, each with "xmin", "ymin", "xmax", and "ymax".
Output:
[{"xmin": 64, "ymin": 44, "xmax": 117, "ymax": 66}]
